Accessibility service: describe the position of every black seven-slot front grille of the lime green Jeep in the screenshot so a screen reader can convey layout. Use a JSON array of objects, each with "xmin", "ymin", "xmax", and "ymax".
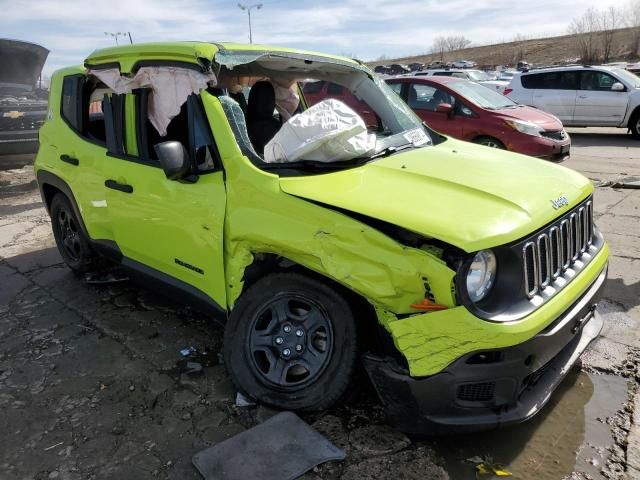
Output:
[{"xmin": 522, "ymin": 200, "xmax": 594, "ymax": 298}]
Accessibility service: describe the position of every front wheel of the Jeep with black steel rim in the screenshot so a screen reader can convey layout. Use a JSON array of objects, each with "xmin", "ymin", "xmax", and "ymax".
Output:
[{"xmin": 224, "ymin": 273, "xmax": 357, "ymax": 411}]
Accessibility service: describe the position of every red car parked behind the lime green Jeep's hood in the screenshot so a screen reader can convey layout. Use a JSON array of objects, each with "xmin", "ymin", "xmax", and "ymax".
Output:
[{"xmin": 386, "ymin": 76, "xmax": 571, "ymax": 161}]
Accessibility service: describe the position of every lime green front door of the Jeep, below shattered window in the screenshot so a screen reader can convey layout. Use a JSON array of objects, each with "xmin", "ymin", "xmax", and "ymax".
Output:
[{"xmin": 103, "ymin": 91, "xmax": 226, "ymax": 309}]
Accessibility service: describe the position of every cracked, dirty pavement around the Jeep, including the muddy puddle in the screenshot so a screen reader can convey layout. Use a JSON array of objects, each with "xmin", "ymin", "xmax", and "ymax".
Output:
[{"xmin": 0, "ymin": 129, "xmax": 640, "ymax": 480}]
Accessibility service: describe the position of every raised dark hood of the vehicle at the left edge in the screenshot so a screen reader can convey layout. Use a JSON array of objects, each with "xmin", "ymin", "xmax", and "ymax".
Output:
[{"xmin": 0, "ymin": 39, "xmax": 49, "ymax": 87}]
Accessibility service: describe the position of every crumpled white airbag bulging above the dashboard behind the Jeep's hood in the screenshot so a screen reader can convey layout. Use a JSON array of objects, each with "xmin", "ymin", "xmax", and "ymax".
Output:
[{"xmin": 264, "ymin": 99, "xmax": 376, "ymax": 163}]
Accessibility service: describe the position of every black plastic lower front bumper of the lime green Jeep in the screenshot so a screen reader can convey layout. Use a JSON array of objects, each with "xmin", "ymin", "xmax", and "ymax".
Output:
[{"xmin": 364, "ymin": 267, "xmax": 607, "ymax": 434}]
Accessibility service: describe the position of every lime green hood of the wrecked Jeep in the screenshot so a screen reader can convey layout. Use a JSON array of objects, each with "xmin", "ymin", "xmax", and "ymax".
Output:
[{"xmin": 280, "ymin": 139, "xmax": 593, "ymax": 252}]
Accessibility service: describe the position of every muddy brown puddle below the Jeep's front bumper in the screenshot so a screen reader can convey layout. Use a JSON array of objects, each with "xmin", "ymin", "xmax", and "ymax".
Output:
[{"xmin": 434, "ymin": 372, "xmax": 627, "ymax": 480}]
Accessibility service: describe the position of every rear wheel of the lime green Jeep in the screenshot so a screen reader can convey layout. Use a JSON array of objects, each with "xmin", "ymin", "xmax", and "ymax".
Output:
[{"xmin": 49, "ymin": 193, "xmax": 96, "ymax": 274}]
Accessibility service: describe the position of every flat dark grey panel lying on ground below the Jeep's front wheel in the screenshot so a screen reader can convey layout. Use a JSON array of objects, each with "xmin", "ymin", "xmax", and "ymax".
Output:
[{"xmin": 193, "ymin": 412, "xmax": 346, "ymax": 480}]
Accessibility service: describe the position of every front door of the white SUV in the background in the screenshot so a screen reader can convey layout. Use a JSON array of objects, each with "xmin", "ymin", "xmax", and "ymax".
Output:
[{"xmin": 574, "ymin": 70, "xmax": 629, "ymax": 127}]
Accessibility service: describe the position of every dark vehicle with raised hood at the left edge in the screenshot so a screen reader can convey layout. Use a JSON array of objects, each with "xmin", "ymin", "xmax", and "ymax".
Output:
[{"xmin": 0, "ymin": 39, "xmax": 49, "ymax": 155}]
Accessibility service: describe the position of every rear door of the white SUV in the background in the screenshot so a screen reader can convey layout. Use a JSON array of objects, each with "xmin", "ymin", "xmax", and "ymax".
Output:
[{"xmin": 521, "ymin": 70, "xmax": 578, "ymax": 125}]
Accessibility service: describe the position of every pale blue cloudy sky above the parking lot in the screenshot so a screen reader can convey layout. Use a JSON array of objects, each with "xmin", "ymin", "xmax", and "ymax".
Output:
[{"xmin": 0, "ymin": 0, "xmax": 620, "ymax": 74}]
